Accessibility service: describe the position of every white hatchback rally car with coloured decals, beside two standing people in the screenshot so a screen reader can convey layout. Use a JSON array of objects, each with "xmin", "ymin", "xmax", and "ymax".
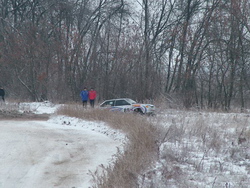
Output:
[{"xmin": 100, "ymin": 98, "xmax": 155, "ymax": 115}]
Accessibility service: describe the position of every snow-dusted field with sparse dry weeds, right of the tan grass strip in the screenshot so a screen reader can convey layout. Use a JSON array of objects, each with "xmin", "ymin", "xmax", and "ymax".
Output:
[{"xmin": 144, "ymin": 109, "xmax": 250, "ymax": 188}]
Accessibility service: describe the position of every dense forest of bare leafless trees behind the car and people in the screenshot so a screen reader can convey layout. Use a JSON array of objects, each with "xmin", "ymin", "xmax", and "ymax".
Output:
[{"xmin": 0, "ymin": 0, "xmax": 250, "ymax": 111}]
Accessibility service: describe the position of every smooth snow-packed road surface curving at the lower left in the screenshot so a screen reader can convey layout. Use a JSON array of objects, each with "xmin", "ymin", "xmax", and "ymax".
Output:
[{"xmin": 0, "ymin": 120, "xmax": 121, "ymax": 188}]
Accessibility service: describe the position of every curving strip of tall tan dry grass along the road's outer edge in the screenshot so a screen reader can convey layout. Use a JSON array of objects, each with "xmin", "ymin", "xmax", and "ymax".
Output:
[{"xmin": 58, "ymin": 105, "xmax": 159, "ymax": 188}]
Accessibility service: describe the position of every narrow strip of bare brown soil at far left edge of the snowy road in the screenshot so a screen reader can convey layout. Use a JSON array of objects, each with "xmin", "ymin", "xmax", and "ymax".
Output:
[{"xmin": 0, "ymin": 110, "xmax": 50, "ymax": 120}]
